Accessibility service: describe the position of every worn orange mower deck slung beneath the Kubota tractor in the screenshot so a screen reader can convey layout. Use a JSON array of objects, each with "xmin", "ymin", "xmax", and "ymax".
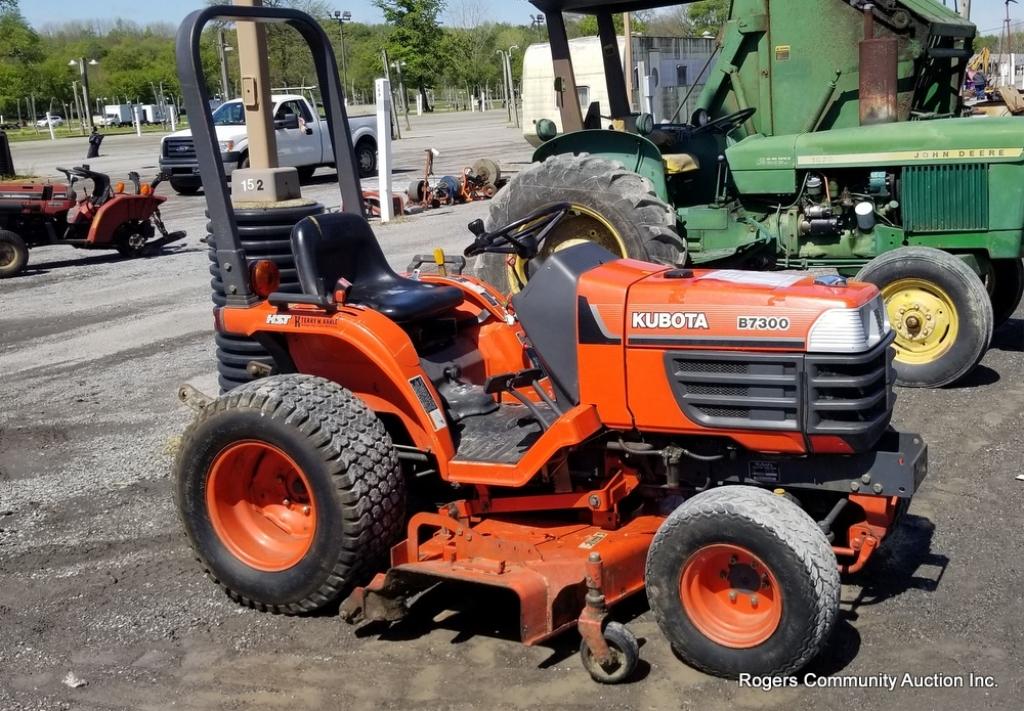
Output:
[{"xmin": 342, "ymin": 513, "xmax": 665, "ymax": 644}]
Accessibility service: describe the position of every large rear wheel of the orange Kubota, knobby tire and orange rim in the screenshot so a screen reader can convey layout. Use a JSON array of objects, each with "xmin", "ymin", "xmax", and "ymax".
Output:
[{"xmin": 174, "ymin": 375, "xmax": 406, "ymax": 614}]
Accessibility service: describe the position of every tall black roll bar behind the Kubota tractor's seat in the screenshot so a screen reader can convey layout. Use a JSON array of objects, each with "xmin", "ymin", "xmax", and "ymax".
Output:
[{"xmin": 175, "ymin": 5, "xmax": 364, "ymax": 305}]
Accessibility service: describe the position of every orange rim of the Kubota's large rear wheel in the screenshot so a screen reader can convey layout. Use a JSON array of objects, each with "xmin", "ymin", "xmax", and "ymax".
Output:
[{"xmin": 206, "ymin": 440, "xmax": 316, "ymax": 572}]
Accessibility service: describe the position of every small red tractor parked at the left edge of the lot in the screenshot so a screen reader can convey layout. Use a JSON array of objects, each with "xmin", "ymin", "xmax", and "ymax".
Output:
[{"xmin": 0, "ymin": 165, "xmax": 185, "ymax": 279}]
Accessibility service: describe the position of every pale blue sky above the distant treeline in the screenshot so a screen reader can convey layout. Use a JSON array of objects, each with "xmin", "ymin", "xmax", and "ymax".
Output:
[{"xmin": 20, "ymin": 0, "xmax": 1011, "ymax": 34}]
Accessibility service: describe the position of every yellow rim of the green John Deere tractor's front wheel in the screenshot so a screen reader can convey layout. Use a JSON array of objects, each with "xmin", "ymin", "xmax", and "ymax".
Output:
[{"xmin": 882, "ymin": 278, "xmax": 959, "ymax": 365}]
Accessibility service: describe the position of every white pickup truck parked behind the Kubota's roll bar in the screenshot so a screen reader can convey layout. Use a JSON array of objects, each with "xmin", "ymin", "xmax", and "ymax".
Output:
[{"xmin": 160, "ymin": 94, "xmax": 377, "ymax": 195}]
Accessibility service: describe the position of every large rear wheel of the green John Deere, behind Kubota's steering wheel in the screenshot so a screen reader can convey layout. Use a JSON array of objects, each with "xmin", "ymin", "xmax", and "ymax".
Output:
[{"xmin": 469, "ymin": 154, "xmax": 686, "ymax": 294}]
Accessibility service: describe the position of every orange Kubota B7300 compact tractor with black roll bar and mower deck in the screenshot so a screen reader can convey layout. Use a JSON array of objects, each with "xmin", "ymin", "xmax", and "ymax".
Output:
[{"xmin": 169, "ymin": 7, "xmax": 927, "ymax": 682}]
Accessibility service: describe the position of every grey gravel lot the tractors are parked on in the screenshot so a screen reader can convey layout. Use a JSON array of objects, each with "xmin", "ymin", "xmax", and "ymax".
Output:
[{"xmin": 0, "ymin": 114, "xmax": 1024, "ymax": 711}]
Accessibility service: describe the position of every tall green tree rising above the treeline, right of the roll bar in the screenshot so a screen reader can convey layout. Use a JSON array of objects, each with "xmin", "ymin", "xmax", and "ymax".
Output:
[{"xmin": 374, "ymin": 0, "xmax": 444, "ymax": 112}]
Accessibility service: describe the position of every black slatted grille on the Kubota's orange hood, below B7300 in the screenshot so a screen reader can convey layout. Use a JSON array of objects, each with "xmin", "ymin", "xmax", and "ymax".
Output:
[{"xmin": 666, "ymin": 336, "xmax": 895, "ymax": 448}]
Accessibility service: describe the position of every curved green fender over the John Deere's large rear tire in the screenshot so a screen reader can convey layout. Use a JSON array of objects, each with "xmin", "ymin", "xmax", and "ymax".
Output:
[{"xmin": 534, "ymin": 129, "xmax": 672, "ymax": 204}]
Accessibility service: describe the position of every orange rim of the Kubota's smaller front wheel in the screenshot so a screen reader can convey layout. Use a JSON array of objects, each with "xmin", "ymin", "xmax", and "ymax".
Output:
[{"xmin": 679, "ymin": 543, "xmax": 782, "ymax": 650}]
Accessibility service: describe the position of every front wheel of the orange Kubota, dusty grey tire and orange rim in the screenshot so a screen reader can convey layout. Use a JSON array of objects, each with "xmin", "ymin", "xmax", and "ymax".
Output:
[{"xmin": 645, "ymin": 487, "xmax": 840, "ymax": 678}]
